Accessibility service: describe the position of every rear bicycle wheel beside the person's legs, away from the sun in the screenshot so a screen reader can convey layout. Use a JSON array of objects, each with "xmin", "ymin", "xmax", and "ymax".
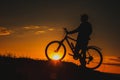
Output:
[{"xmin": 86, "ymin": 46, "xmax": 103, "ymax": 69}]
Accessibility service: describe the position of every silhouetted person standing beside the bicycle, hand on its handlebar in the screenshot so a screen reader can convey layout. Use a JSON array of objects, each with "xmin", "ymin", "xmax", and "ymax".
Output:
[{"xmin": 67, "ymin": 14, "xmax": 92, "ymax": 67}]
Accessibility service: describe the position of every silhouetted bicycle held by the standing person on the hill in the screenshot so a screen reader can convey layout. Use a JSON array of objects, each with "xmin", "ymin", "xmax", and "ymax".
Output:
[{"xmin": 45, "ymin": 28, "xmax": 103, "ymax": 69}]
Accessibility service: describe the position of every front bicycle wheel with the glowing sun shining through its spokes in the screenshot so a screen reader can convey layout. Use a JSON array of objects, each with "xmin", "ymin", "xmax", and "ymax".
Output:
[{"xmin": 45, "ymin": 41, "xmax": 66, "ymax": 60}]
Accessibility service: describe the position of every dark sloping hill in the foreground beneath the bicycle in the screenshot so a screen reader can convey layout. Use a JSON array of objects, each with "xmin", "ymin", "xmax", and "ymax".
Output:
[{"xmin": 0, "ymin": 56, "xmax": 120, "ymax": 80}]
